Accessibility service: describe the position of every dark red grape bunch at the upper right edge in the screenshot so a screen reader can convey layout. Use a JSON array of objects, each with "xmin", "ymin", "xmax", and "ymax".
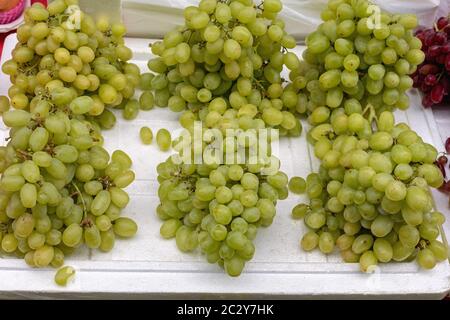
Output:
[{"xmin": 413, "ymin": 17, "xmax": 450, "ymax": 108}]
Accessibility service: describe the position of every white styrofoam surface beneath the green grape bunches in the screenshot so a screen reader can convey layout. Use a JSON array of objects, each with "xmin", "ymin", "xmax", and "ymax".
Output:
[{"xmin": 0, "ymin": 35, "xmax": 450, "ymax": 299}]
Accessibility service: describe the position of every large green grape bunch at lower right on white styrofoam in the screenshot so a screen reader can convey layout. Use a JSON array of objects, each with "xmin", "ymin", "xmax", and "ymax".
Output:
[{"xmin": 298, "ymin": 109, "xmax": 448, "ymax": 271}]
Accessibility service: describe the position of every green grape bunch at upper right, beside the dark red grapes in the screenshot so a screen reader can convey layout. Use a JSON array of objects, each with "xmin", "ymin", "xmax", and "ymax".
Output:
[{"xmin": 290, "ymin": 0, "xmax": 425, "ymax": 116}]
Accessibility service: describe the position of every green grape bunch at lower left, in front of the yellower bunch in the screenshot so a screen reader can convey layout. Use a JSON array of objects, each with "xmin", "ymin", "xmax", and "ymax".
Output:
[{"xmin": 0, "ymin": 107, "xmax": 137, "ymax": 267}]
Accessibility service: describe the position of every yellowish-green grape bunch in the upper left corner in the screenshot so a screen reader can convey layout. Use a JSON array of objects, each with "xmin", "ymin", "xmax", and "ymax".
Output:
[{"xmin": 2, "ymin": 0, "xmax": 141, "ymax": 128}]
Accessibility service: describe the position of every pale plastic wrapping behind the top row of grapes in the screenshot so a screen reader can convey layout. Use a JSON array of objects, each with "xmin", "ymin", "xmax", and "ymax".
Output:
[{"xmin": 122, "ymin": 0, "xmax": 450, "ymax": 42}]
